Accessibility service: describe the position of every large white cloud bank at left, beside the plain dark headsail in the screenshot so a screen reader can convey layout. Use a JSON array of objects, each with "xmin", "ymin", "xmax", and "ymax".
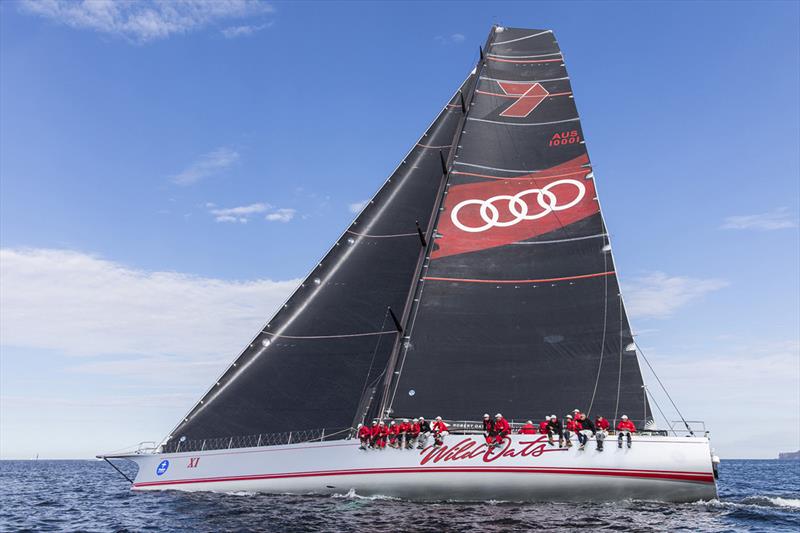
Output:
[{"xmin": 0, "ymin": 248, "xmax": 299, "ymax": 360}]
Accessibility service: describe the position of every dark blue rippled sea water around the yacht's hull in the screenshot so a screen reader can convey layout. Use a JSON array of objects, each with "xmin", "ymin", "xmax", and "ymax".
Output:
[{"xmin": 0, "ymin": 460, "xmax": 800, "ymax": 533}]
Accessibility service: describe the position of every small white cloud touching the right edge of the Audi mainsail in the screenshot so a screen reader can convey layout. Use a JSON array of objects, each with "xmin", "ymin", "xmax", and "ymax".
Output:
[{"xmin": 623, "ymin": 272, "xmax": 728, "ymax": 318}]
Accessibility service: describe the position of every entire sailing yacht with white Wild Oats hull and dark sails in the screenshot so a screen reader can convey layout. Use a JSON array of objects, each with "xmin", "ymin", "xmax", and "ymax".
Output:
[{"xmin": 99, "ymin": 26, "xmax": 716, "ymax": 501}]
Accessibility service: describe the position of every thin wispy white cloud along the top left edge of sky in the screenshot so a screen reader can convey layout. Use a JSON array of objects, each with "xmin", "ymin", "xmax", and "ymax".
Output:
[{"xmin": 21, "ymin": 0, "xmax": 274, "ymax": 43}]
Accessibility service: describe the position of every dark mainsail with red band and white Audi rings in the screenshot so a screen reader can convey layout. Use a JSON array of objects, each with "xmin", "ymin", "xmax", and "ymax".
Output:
[{"xmin": 386, "ymin": 28, "xmax": 649, "ymax": 420}]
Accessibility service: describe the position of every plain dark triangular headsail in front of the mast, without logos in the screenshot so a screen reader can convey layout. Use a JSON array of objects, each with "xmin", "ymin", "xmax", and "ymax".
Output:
[{"xmin": 165, "ymin": 74, "xmax": 476, "ymax": 451}]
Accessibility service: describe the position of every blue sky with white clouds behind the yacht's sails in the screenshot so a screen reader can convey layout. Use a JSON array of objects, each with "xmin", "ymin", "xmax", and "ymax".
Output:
[{"xmin": 0, "ymin": 0, "xmax": 800, "ymax": 458}]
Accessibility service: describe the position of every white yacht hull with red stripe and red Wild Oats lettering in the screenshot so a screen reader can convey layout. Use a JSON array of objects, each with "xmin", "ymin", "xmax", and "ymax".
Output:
[{"xmin": 109, "ymin": 435, "xmax": 717, "ymax": 502}]
